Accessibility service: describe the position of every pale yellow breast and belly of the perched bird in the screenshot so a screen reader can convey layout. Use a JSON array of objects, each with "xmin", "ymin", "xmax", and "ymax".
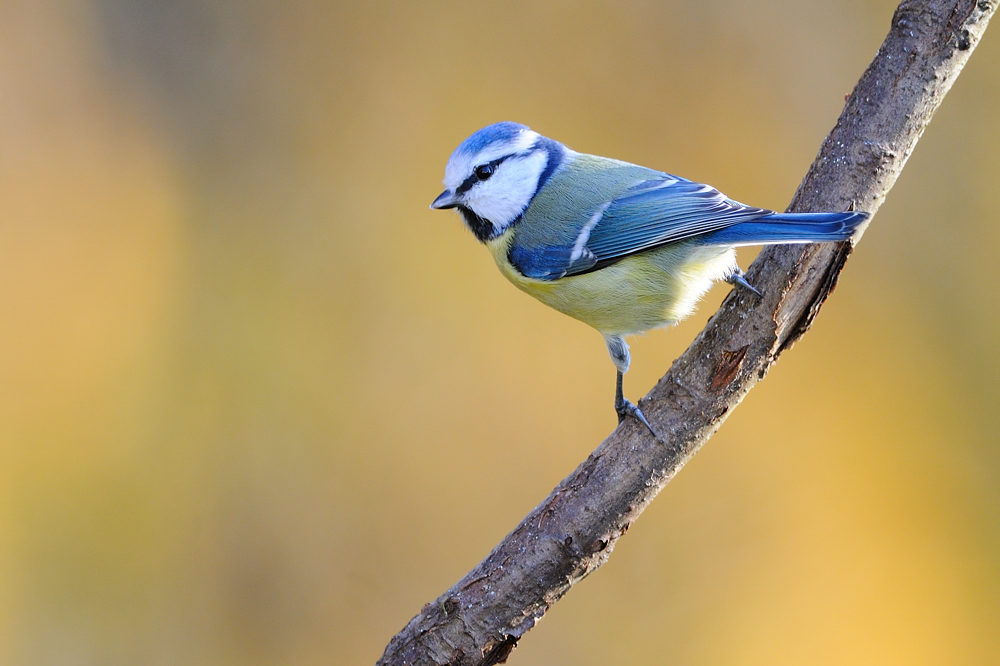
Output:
[{"xmin": 487, "ymin": 229, "xmax": 736, "ymax": 335}]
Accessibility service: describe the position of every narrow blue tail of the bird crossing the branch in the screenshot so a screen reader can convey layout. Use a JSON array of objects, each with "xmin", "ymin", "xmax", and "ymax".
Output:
[{"xmin": 702, "ymin": 212, "xmax": 870, "ymax": 246}]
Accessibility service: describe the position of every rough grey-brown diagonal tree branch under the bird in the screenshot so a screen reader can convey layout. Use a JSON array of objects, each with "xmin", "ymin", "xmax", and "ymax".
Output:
[{"xmin": 378, "ymin": 0, "xmax": 997, "ymax": 666}]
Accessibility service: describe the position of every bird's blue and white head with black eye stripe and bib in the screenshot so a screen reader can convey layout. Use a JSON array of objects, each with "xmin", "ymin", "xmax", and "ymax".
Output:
[{"xmin": 431, "ymin": 122, "xmax": 568, "ymax": 242}]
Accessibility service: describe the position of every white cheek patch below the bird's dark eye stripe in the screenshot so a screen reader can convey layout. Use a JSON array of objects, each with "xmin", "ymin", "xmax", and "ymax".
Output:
[{"xmin": 466, "ymin": 152, "xmax": 548, "ymax": 232}]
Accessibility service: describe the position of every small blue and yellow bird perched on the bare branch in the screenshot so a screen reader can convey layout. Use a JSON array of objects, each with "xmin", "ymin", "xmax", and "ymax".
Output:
[{"xmin": 431, "ymin": 122, "xmax": 868, "ymax": 436}]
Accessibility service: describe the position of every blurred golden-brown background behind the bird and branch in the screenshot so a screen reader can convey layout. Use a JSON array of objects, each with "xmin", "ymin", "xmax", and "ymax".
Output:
[{"xmin": 0, "ymin": 0, "xmax": 1000, "ymax": 665}]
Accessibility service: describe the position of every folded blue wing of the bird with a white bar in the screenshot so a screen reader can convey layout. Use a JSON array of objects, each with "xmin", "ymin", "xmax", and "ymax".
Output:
[{"xmin": 510, "ymin": 174, "xmax": 772, "ymax": 280}]
